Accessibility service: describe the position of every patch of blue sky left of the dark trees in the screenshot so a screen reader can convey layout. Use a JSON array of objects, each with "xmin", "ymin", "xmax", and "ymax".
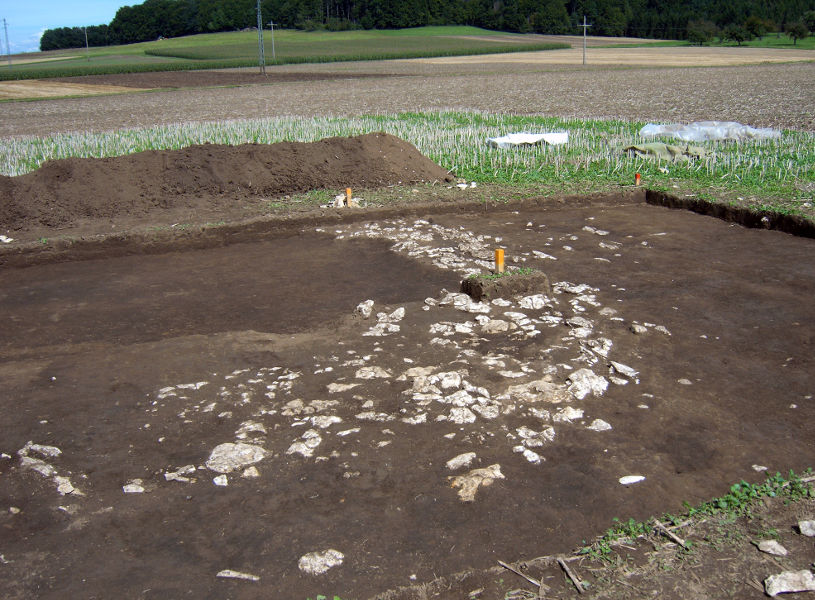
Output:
[{"xmin": 0, "ymin": 0, "xmax": 127, "ymax": 56}]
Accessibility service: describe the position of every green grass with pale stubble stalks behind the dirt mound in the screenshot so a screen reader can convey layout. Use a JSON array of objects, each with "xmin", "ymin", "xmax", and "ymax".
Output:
[{"xmin": 0, "ymin": 112, "xmax": 815, "ymax": 219}]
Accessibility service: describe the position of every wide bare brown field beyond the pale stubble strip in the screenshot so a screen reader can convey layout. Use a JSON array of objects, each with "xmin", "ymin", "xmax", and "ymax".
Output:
[{"xmin": 0, "ymin": 48, "xmax": 815, "ymax": 136}]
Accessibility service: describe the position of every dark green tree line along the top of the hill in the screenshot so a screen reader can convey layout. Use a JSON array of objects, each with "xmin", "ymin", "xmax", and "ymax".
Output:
[{"xmin": 40, "ymin": 0, "xmax": 815, "ymax": 50}]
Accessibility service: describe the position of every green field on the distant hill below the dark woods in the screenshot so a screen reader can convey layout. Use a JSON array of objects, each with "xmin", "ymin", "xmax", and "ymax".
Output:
[{"xmin": 0, "ymin": 26, "xmax": 569, "ymax": 80}]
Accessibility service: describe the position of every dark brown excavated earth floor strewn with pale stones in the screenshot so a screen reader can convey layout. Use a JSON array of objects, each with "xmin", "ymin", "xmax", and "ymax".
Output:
[{"xmin": 0, "ymin": 137, "xmax": 815, "ymax": 599}]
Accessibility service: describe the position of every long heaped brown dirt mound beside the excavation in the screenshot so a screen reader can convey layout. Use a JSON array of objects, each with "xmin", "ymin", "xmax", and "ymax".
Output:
[{"xmin": 0, "ymin": 133, "xmax": 450, "ymax": 230}]
